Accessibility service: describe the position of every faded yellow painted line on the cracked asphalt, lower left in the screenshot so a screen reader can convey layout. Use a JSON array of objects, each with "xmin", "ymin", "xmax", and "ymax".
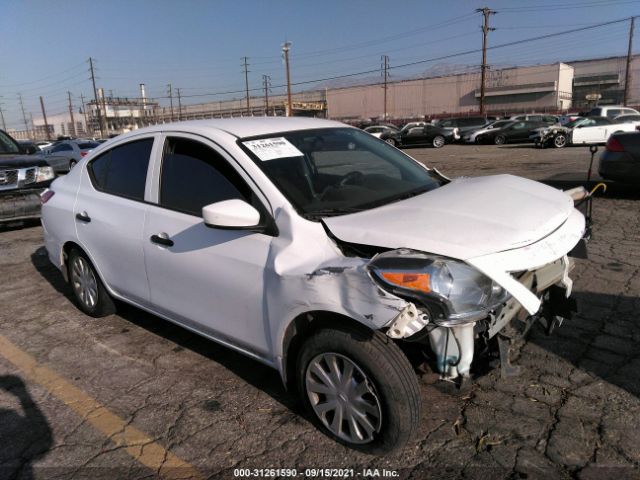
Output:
[{"xmin": 0, "ymin": 335, "xmax": 204, "ymax": 479}]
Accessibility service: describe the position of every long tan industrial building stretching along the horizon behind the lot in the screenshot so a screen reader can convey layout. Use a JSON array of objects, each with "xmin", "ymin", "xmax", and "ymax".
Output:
[{"xmin": 18, "ymin": 55, "xmax": 640, "ymax": 138}]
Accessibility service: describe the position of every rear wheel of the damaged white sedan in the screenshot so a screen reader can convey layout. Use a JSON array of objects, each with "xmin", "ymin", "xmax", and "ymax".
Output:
[{"xmin": 67, "ymin": 248, "xmax": 116, "ymax": 318}]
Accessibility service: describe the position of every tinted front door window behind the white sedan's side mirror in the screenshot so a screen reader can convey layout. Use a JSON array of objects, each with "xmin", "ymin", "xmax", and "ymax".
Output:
[{"xmin": 160, "ymin": 138, "xmax": 255, "ymax": 217}]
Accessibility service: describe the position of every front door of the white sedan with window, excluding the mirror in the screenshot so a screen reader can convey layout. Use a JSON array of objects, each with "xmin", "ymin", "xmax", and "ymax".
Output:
[{"xmin": 143, "ymin": 134, "xmax": 272, "ymax": 358}]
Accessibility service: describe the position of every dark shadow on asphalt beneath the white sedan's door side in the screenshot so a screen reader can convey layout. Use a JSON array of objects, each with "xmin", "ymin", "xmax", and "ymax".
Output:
[{"xmin": 31, "ymin": 247, "xmax": 312, "ymax": 421}]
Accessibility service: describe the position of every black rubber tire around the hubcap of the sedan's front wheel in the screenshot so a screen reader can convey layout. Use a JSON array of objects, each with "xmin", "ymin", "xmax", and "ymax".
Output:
[{"xmin": 296, "ymin": 328, "xmax": 421, "ymax": 454}]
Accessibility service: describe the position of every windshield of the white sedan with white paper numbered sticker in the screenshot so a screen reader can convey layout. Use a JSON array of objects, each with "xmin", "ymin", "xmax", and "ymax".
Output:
[{"xmin": 238, "ymin": 128, "xmax": 443, "ymax": 219}]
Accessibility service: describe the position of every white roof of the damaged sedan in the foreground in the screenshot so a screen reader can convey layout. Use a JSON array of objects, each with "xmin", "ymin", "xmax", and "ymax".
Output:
[{"xmin": 117, "ymin": 117, "xmax": 344, "ymax": 139}]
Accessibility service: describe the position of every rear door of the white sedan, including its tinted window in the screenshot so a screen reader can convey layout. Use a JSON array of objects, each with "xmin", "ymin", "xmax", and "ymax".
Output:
[{"xmin": 74, "ymin": 136, "xmax": 154, "ymax": 305}]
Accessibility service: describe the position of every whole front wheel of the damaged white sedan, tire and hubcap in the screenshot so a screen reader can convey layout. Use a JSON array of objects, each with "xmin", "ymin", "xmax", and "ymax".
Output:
[{"xmin": 297, "ymin": 329, "xmax": 420, "ymax": 453}]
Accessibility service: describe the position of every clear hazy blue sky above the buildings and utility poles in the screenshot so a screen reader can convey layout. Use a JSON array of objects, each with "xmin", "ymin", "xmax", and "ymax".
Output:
[{"xmin": 0, "ymin": 0, "xmax": 640, "ymax": 129}]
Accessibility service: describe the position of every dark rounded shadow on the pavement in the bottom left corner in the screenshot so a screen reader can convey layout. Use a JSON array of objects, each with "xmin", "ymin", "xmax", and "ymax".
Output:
[{"xmin": 0, "ymin": 375, "xmax": 53, "ymax": 480}]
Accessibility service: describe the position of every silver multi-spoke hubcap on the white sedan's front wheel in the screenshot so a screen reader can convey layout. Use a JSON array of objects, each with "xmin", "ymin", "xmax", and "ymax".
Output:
[{"xmin": 305, "ymin": 353, "xmax": 382, "ymax": 444}]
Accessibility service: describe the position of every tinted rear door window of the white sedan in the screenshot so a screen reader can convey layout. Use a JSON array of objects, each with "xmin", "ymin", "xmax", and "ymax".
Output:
[{"xmin": 88, "ymin": 138, "xmax": 153, "ymax": 201}]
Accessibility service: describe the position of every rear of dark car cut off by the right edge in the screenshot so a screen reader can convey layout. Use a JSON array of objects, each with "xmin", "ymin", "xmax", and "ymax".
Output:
[{"xmin": 598, "ymin": 132, "xmax": 640, "ymax": 185}]
